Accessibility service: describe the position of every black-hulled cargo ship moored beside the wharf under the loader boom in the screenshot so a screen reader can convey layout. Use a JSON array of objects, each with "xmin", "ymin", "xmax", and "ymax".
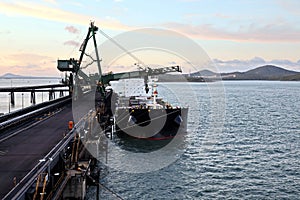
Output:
[{"xmin": 114, "ymin": 79, "xmax": 188, "ymax": 140}]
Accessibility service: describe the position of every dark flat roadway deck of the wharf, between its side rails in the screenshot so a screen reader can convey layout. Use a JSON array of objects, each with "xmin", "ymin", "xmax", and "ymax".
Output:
[{"xmin": 0, "ymin": 103, "xmax": 73, "ymax": 199}]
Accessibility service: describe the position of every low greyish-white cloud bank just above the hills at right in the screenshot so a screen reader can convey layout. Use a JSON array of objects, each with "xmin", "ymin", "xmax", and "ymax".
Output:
[{"xmin": 213, "ymin": 57, "xmax": 300, "ymax": 72}]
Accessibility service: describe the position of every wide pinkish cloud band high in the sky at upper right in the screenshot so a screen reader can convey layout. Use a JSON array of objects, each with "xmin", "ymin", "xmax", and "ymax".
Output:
[{"xmin": 162, "ymin": 22, "xmax": 300, "ymax": 43}]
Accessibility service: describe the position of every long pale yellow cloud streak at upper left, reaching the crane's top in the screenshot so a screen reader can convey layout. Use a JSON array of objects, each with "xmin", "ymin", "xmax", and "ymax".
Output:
[{"xmin": 0, "ymin": 2, "xmax": 133, "ymax": 30}]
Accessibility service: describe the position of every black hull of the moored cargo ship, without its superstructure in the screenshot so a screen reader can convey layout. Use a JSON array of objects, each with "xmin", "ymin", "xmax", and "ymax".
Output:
[{"xmin": 115, "ymin": 108, "xmax": 188, "ymax": 140}]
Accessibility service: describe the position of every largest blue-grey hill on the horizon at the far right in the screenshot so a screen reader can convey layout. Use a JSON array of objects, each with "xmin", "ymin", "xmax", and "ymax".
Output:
[{"xmin": 221, "ymin": 65, "xmax": 300, "ymax": 80}]
